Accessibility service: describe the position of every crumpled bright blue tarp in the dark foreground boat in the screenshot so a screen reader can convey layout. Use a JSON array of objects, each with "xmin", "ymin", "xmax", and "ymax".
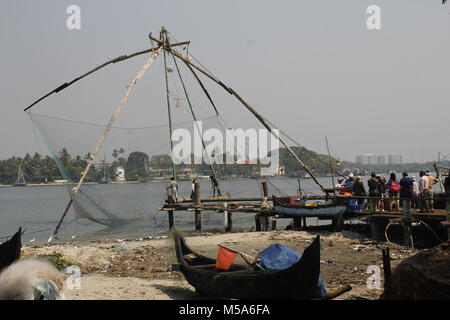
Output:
[{"xmin": 256, "ymin": 243, "xmax": 327, "ymax": 298}]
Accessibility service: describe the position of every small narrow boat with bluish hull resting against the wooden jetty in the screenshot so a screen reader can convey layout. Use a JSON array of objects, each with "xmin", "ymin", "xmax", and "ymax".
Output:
[{"xmin": 272, "ymin": 196, "xmax": 347, "ymax": 218}]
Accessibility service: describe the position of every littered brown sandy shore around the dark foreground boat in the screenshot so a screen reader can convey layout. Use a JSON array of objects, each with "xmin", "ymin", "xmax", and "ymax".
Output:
[{"xmin": 18, "ymin": 231, "xmax": 416, "ymax": 300}]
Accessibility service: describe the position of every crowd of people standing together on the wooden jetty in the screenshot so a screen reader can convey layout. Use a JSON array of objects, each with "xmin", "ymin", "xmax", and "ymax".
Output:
[{"xmin": 336, "ymin": 170, "xmax": 450, "ymax": 212}]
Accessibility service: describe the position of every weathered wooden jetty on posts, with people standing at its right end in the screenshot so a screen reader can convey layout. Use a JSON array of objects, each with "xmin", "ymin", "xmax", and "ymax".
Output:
[{"xmin": 159, "ymin": 181, "xmax": 450, "ymax": 246}]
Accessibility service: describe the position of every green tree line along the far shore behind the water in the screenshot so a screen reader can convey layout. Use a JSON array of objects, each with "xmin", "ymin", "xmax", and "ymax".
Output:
[{"xmin": 0, "ymin": 147, "xmax": 344, "ymax": 184}]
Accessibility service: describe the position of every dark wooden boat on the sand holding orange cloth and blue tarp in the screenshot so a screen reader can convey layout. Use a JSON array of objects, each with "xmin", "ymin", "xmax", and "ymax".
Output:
[{"xmin": 173, "ymin": 232, "xmax": 320, "ymax": 299}]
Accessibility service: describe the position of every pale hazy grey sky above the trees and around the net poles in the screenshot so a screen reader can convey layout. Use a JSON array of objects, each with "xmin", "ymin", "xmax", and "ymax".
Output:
[{"xmin": 0, "ymin": 0, "xmax": 450, "ymax": 161}]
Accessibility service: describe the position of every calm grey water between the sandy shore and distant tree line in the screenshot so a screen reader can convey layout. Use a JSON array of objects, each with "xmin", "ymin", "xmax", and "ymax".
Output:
[{"xmin": 0, "ymin": 177, "xmax": 422, "ymax": 243}]
